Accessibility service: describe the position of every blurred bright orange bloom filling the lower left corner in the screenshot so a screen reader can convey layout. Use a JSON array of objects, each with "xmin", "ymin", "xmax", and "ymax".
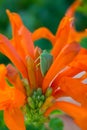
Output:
[{"xmin": 0, "ymin": 64, "xmax": 25, "ymax": 130}]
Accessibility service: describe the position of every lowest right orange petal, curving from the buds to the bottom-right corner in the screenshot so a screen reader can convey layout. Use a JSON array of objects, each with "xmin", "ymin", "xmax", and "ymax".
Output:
[{"xmin": 45, "ymin": 102, "xmax": 87, "ymax": 130}]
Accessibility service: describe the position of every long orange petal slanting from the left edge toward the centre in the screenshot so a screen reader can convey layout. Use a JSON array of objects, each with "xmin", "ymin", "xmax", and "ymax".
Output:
[{"xmin": 0, "ymin": 34, "xmax": 27, "ymax": 77}]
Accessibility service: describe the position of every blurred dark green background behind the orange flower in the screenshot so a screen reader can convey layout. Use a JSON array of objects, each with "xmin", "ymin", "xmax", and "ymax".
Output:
[{"xmin": 0, "ymin": 0, "xmax": 87, "ymax": 130}]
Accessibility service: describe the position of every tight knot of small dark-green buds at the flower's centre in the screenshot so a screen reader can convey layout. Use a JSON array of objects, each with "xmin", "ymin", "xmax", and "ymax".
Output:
[{"xmin": 27, "ymin": 88, "xmax": 45, "ymax": 109}]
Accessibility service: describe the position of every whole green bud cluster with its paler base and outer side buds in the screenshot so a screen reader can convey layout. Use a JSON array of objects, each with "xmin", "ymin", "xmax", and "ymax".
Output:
[{"xmin": 22, "ymin": 86, "xmax": 52, "ymax": 126}]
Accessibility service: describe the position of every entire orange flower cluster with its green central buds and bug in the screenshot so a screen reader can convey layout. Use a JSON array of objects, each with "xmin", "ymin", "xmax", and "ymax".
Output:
[{"xmin": 0, "ymin": 1, "xmax": 87, "ymax": 130}]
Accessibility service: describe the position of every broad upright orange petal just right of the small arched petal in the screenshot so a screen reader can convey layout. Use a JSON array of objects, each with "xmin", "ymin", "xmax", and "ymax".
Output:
[{"xmin": 51, "ymin": 17, "xmax": 72, "ymax": 58}]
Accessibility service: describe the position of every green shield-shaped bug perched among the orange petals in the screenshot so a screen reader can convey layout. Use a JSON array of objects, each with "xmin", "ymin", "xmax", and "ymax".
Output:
[{"xmin": 40, "ymin": 50, "xmax": 53, "ymax": 76}]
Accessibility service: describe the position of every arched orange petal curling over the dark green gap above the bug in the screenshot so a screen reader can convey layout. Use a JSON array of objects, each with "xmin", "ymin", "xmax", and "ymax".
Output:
[{"xmin": 32, "ymin": 27, "xmax": 55, "ymax": 45}]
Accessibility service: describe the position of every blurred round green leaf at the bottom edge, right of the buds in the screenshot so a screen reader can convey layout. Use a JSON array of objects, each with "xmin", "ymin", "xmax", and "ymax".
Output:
[{"xmin": 49, "ymin": 118, "xmax": 64, "ymax": 130}]
